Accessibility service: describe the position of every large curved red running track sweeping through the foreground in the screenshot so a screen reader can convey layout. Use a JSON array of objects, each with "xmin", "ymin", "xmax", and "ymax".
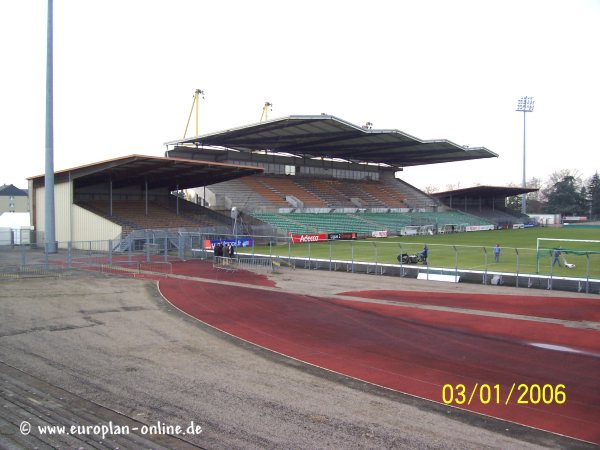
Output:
[{"xmin": 159, "ymin": 279, "xmax": 600, "ymax": 444}]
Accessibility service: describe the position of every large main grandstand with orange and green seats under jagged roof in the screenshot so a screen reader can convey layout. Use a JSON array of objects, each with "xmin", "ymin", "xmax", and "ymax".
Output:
[{"xmin": 166, "ymin": 115, "xmax": 516, "ymax": 236}]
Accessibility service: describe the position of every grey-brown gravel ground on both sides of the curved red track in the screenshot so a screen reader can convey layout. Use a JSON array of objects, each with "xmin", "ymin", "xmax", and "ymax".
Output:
[{"xmin": 0, "ymin": 270, "xmax": 587, "ymax": 449}]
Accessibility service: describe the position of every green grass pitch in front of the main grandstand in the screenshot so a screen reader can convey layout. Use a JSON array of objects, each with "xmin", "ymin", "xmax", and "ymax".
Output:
[{"xmin": 239, "ymin": 227, "xmax": 600, "ymax": 279}]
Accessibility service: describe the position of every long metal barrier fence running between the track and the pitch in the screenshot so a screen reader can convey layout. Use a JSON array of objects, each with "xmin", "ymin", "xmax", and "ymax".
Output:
[{"xmin": 0, "ymin": 234, "xmax": 600, "ymax": 293}]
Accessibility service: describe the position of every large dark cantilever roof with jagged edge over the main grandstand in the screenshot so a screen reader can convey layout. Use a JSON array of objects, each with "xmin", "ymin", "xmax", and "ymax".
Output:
[{"xmin": 166, "ymin": 115, "xmax": 498, "ymax": 168}]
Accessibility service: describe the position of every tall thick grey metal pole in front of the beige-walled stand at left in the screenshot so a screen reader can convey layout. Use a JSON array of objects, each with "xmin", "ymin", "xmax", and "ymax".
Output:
[{"xmin": 44, "ymin": 0, "xmax": 57, "ymax": 253}]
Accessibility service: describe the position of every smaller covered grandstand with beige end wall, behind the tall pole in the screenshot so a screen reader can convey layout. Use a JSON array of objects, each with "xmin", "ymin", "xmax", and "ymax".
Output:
[{"xmin": 28, "ymin": 155, "xmax": 262, "ymax": 244}]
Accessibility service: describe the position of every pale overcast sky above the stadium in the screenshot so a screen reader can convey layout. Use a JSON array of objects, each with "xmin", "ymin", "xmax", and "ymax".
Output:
[{"xmin": 0, "ymin": 0, "xmax": 600, "ymax": 190}]
